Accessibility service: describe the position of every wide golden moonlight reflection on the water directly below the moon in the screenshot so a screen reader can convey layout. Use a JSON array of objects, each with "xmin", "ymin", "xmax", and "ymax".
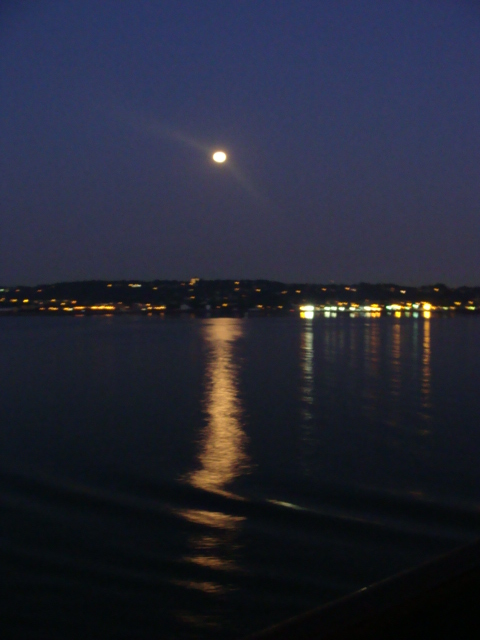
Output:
[{"xmin": 176, "ymin": 318, "xmax": 249, "ymax": 604}]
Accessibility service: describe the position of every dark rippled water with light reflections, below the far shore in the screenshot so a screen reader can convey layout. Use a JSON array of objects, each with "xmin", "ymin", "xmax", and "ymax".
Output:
[{"xmin": 0, "ymin": 316, "xmax": 480, "ymax": 640}]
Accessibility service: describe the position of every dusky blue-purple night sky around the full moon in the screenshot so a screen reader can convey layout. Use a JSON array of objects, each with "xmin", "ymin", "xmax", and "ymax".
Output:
[{"xmin": 0, "ymin": 0, "xmax": 480, "ymax": 285}]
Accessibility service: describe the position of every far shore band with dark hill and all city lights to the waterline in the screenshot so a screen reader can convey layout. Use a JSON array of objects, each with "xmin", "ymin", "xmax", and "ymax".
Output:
[{"xmin": 0, "ymin": 278, "xmax": 480, "ymax": 319}]
